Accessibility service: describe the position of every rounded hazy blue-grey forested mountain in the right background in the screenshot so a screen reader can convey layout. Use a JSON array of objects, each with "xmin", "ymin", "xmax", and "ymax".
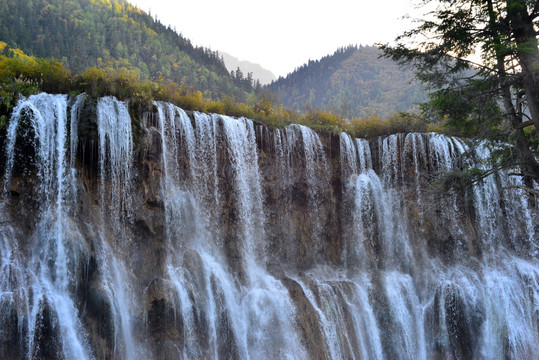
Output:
[{"xmin": 269, "ymin": 46, "xmax": 426, "ymax": 117}]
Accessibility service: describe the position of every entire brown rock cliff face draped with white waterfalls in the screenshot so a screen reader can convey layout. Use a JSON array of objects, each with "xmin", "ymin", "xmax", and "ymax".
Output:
[{"xmin": 0, "ymin": 94, "xmax": 539, "ymax": 359}]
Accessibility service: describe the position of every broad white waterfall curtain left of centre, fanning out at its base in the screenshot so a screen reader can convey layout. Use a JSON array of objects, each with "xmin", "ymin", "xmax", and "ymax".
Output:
[{"xmin": 156, "ymin": 103, "xmax": 303, "ymax": 359}]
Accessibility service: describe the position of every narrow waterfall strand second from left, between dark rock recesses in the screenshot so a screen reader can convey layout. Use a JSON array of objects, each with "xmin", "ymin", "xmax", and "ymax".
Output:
[{"xmin": 95, "ymin": 97, "xmax": 145, "ymax": 359}]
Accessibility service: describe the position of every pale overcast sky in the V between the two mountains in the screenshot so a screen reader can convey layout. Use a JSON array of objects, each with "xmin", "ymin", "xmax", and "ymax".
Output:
[{"xmin": 129, "ymin": 0, "xmax": 424, "ymax": 76}]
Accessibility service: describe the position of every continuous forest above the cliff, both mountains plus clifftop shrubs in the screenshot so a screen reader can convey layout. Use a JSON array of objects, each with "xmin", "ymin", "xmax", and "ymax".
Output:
[{"xmin": 0, "ymin": 0, "xmax": 460, "ymax": 137}]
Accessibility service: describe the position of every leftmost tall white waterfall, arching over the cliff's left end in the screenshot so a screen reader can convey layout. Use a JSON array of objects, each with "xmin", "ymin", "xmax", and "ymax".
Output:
[{"xmin": 2, "ymin": 94, "xmax": 93, "ymax": 359}]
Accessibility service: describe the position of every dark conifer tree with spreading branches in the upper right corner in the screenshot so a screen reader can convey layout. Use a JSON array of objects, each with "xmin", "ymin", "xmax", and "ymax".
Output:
[{"xmin": 382, "ymin": 0, "xmax": 539, "ymax": 190}]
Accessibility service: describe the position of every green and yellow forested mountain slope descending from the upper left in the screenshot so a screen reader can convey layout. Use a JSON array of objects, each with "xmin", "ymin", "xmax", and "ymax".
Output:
[{"xmin": 0, "ymin": 0, "xmax": 252, "ymax": 100}]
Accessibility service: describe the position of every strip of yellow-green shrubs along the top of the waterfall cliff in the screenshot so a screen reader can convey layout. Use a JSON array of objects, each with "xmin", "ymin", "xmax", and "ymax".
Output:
[{"xmin": 0, "ymin": 43, "xmax": 434, "ymax": 141}]
